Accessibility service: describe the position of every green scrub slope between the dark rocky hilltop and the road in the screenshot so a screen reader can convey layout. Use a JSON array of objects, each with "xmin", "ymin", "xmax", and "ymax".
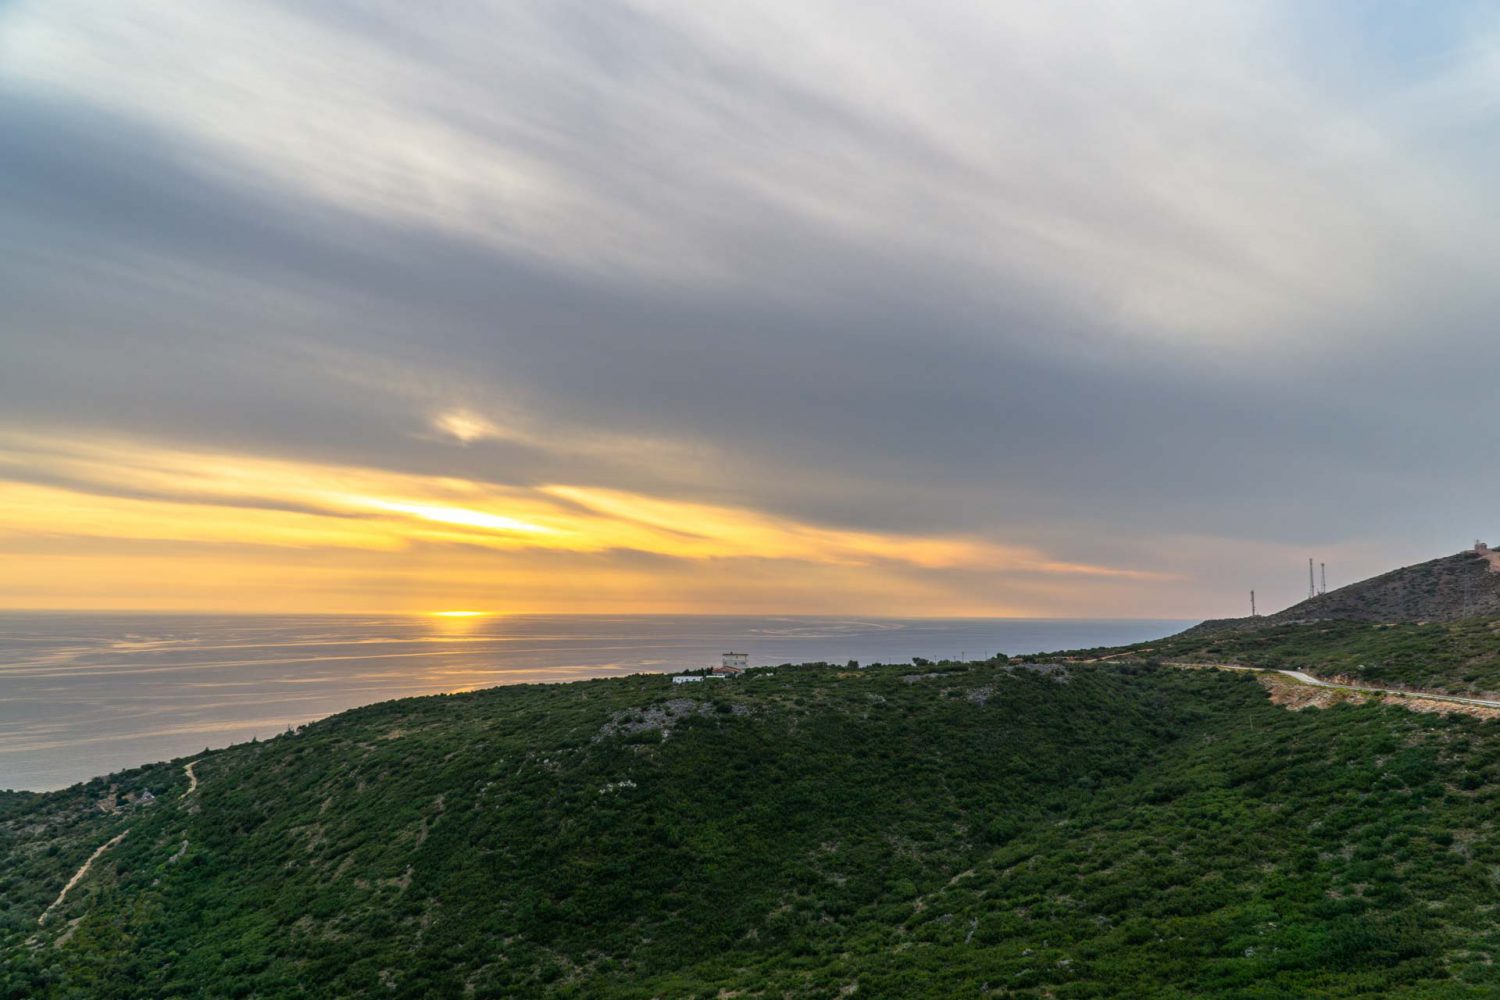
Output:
[{"xmin": 1106, "ymin": 618, "xmax": 1500, "ymax": 694}]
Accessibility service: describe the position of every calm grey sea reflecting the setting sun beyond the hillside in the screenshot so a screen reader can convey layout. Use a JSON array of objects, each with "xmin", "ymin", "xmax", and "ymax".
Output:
[{"xmin": 0, "ymin": 612, "xmax": 1193, "ymax": 790}]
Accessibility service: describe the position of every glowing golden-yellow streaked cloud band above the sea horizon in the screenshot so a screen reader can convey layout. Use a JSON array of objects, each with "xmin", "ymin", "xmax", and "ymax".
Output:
[{"xmin": 0, "ymin": 436, "xmax": 1151, "ymax": 569}]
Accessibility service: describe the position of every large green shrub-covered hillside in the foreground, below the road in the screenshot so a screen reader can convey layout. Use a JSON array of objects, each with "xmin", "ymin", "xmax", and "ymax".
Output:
[{"xmin": 0, "ymin": 663, "xmax": 1500, "ymax": 999}]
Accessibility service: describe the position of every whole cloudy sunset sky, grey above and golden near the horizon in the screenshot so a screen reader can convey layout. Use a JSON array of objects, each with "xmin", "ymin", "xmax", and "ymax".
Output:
[{"xmin": 0, "ymin": 0, "xmax": 1500, "ymax": 618}]
